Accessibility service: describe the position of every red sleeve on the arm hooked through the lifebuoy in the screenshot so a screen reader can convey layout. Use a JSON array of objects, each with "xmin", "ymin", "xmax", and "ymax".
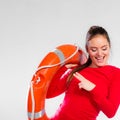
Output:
[{"xmin": 46, "ymin": 66, "xmax": 72, "ymax": 98}]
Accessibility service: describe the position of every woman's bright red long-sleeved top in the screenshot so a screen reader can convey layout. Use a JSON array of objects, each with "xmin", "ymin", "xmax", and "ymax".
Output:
[{"xmin": 47, "ymin": 65, "xmax": 120, "ymax": 120}]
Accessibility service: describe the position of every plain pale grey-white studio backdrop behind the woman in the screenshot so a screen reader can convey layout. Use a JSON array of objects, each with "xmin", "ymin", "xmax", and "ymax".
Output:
[{"xmin": 0, "ymin": 0, "xmax": 120, "ymax": 120}]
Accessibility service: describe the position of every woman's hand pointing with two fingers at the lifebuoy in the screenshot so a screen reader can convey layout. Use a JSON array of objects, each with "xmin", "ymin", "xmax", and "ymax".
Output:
[{"xmin": 73, "ymin": 72, "xmax": 96, "ymax": 91}]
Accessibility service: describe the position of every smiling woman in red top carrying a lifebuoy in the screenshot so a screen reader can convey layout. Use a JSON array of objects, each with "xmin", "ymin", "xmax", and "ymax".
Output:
[{"xmin": 47, "ymin": 26, "xmax": 120, "ymax": 120}]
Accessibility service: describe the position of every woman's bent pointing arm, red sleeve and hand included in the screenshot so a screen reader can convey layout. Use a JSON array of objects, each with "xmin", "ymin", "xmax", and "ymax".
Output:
[{"xmin": 74, "ymin": 72, "xmax": 120, "ymax": 118}]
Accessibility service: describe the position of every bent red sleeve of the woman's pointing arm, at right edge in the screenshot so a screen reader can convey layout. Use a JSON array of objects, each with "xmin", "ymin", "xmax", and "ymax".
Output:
[{"xmin": 90, "ymin": 71, "xmax": 120, "ymax": 118}]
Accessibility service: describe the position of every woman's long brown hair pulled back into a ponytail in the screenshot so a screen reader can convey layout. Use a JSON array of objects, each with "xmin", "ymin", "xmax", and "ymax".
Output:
[{"xmin": 67, "ymin": 26, "xmax": 111, "ymax": 86}]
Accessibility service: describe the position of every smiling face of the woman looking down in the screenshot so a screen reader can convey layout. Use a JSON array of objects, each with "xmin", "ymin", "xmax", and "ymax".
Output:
[{"xmin": 87, "ymin": 35, "xmax": 110, "ymax": 67}]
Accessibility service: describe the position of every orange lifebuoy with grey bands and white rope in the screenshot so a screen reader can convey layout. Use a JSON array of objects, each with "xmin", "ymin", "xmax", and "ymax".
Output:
[{"xmin": 27, "ymin": 44, "xmax": 86, "ymax": 120}]
